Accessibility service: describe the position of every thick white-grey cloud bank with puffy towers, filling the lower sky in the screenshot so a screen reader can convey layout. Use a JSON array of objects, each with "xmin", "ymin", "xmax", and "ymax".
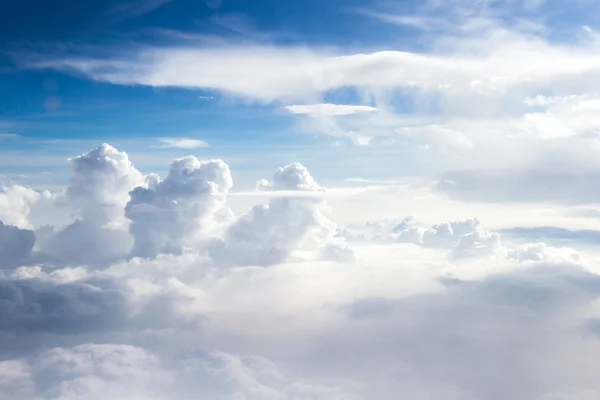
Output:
[{"xmin": 0, "ymin": 144, "xmax": 600, "ymax": 400}]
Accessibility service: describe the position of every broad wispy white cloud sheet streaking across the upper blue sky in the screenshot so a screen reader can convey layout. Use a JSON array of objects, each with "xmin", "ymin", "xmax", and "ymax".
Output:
[{"xmin": 24, "ymin": 13, "xmax": 600, "ymax": 172}]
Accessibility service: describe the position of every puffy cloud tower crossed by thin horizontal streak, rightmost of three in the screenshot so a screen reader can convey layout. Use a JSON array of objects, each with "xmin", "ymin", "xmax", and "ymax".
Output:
[{"xmin": 211, "ymin": 163, "xmax": 355, "ymax": 266}]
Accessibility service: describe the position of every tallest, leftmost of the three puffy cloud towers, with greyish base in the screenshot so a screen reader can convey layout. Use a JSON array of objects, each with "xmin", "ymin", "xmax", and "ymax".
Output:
[{"xmin": 31, "ymin": 144, "xmax": 144, "ymax": 265}]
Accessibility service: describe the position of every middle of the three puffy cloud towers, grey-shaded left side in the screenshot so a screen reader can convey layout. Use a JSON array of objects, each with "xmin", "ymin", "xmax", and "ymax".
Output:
[{"xmin": 125, "ymin": 156, "xmax": 233, "ymax": 257}]
